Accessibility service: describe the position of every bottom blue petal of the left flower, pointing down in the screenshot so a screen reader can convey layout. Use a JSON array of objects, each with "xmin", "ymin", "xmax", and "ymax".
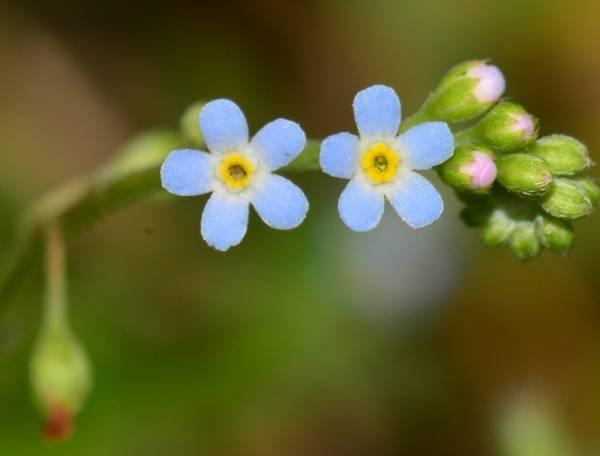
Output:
[{"xmin": 201, "ymin": 193, "xmax": 249, "ymax": 252}]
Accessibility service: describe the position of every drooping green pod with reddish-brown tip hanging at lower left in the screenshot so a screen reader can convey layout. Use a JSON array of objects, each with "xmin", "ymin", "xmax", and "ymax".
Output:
[{"xmin": 31, "ymin": 324, "xmax": 91, "ymax": 439}]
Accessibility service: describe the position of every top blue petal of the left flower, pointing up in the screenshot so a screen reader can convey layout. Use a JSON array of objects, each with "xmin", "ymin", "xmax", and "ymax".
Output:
[{"xmin": 200, "ymin": 99, "xmax": 248, "ymax": 153}]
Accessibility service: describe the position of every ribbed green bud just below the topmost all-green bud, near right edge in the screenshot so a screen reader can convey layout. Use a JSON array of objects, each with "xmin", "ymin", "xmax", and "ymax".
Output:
[{"xmin": 541, "ymin": 177, "xmax": 593, "ymax": 220}]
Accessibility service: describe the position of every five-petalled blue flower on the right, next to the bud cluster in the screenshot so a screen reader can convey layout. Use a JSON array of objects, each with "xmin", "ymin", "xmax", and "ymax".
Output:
[{"xmin": 320, "ymin": 85, "xmax": 454, "ymax": 231}]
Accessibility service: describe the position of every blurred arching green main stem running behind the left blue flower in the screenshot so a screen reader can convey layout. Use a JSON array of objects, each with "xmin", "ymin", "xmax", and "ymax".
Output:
[{"xmin": 0, "ymin": 132, "xmax": 320, "ymax": 306}]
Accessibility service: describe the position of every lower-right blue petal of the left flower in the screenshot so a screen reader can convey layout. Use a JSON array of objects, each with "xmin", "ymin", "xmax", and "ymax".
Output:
[{"xmin": 252, "ymin": 174, "xmax": 308, "ymax": 230}]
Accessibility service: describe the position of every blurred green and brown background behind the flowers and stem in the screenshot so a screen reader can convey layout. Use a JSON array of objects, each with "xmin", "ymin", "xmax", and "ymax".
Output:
[{"xmin": 0, "ymin": 0, "xmax": 600, "ymax": 456}]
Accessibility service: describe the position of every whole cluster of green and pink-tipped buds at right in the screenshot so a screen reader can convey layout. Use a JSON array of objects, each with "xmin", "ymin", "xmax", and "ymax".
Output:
[{"xmin": 421, "ymin": 61, "xmax": 600, "ymax": 260}]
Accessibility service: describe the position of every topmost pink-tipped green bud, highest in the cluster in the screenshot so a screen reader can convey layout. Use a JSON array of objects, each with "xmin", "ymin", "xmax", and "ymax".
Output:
[{"xmin": 423, "ymin": 60, "xmax": 506, "ymax": 123}]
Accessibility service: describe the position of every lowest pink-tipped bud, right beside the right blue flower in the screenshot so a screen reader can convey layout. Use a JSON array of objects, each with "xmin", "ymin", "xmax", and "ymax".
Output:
[{"xmin": 438, "ymin": 145, "xmax": 497, "ymax": 193}]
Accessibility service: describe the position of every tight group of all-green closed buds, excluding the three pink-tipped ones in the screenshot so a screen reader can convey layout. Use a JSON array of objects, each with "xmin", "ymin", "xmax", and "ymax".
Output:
[{"xmin": 460, "ymin": 135, "xmax": 600, "ymax": 260}]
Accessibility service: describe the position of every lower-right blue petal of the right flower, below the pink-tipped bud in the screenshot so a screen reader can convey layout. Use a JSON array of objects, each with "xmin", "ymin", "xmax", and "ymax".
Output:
[{"xmin": 386, "ymin": 172, "xmax": 444, "ymax": 228}]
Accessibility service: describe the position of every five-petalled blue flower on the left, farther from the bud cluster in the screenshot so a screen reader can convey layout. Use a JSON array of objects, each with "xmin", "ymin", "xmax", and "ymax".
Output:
[{"xmin": 160, "ymin": 99, "xmax": 308, "ymax": 251}]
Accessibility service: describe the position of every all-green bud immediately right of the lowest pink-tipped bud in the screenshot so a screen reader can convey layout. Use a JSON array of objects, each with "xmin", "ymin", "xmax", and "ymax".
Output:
[{"xmin": 496, "ymin": 153, "xmax": 552, "ymax": 195}]
